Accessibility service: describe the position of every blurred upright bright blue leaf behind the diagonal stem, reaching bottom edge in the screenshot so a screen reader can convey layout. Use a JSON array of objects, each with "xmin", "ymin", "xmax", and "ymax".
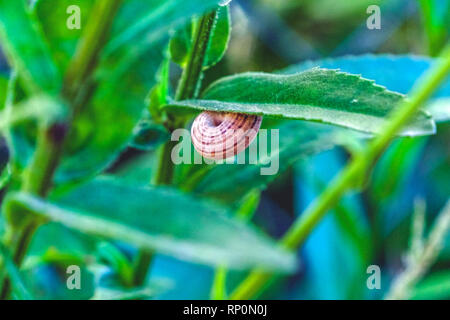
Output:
[{"xmin": 292, "ymin": 150, "xmax": 373, "ymax": 299}]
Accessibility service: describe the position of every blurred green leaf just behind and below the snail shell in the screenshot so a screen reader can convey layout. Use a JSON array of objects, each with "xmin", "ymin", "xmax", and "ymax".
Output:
[{"xmin": 177, "ymin": 121, "xmax": 362, "ymax": 202}]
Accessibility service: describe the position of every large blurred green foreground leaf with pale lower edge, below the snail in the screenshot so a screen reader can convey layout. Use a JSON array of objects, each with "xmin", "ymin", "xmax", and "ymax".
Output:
[{"xmin": 6, "ymin": 179, "xmax": 295, "ymax": 271}]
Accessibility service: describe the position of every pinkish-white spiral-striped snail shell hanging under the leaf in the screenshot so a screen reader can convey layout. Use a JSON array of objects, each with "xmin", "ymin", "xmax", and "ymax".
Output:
[{"xmin": 191, "ymin": 111, "xmax": 262, "ymax": 160}]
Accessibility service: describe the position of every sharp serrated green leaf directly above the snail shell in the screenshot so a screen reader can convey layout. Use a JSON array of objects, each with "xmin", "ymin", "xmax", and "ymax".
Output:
[{"xmin": 167, "ymin": 68, "xmax": 435, "ymax": 136}]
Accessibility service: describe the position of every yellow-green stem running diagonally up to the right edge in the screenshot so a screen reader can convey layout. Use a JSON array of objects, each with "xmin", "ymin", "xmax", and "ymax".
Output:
[{"xmin": 231, "ymin": 44, "xmax": 450, "ymax": 299}]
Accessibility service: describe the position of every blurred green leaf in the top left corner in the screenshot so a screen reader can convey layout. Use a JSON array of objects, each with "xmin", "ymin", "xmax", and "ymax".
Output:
[{"xmin": 0, "ymin": 0, "xmax": 61, "ymax": 93}]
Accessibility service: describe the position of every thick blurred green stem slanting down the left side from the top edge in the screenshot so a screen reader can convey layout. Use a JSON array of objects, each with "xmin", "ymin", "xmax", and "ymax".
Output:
[{"xmin": 0, "ymin": 0, "xmax": 121, "ymax": 299}]
